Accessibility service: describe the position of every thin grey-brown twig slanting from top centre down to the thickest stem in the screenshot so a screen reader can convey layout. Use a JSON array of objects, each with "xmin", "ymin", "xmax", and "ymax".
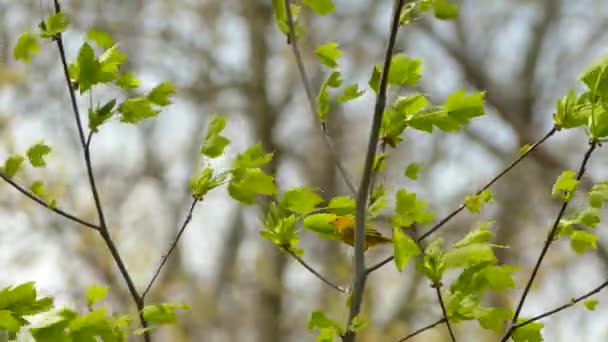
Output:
[{"xmin": 285, "ymin": 0, "xmax": 357, "ymax": 195}]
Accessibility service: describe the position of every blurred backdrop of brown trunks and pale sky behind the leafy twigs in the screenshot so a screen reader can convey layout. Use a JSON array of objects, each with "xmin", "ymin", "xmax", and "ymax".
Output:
[{"xmin": 0, "ymin": 0, "xmax": 608, "ymax": 342}]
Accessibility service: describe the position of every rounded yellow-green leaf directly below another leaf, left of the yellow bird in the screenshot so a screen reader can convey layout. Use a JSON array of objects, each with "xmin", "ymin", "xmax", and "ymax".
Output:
[{"xmin": 228, "ymin": 168, "xmax": 277, "ymax": 204}]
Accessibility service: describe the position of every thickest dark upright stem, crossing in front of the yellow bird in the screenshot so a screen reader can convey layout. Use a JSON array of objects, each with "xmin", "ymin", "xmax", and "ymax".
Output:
[{"xmin": 343, "ymin": 0, "xmax": 404, "ymax": 342}]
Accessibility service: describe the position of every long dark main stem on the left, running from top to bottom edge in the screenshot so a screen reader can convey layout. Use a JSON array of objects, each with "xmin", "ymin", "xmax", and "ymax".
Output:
[{"xmin": 54, "ymin": 0, "xmax": 151, "ymax": 342}]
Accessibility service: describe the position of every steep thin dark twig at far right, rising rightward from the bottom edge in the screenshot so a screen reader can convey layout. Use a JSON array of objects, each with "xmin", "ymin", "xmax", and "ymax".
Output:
[{"xmin": 502, "ymin": 141, "xmax": 597, "ymax": 341}]
